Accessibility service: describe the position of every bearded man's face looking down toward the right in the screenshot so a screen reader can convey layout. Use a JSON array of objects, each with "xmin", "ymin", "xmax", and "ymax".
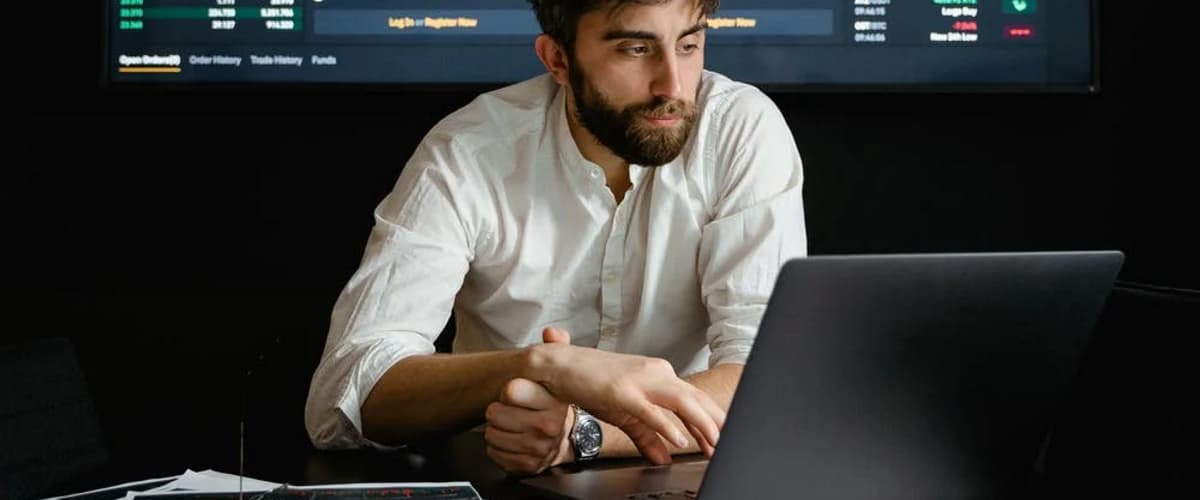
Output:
[{"xmin": 570, "ymin": 0, "xmax": 704, "ymax": 167}]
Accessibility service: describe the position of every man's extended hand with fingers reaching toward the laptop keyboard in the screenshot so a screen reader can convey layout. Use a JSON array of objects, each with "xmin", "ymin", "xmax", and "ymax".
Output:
[{"xmin": 532, "ymin": 329, "xmax": 725, "ymax": 458}]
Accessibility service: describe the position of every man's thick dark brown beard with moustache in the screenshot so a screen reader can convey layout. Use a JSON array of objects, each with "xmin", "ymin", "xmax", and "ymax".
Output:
[{"xmin": 569, "ymin": 62, "xmax": 696, "ymax": 167}]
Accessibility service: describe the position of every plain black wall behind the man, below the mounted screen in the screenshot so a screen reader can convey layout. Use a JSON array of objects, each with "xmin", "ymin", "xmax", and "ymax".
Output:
[{"xmin": 7, "ymin": 2, "xmax": 1200, "ymax": 491}]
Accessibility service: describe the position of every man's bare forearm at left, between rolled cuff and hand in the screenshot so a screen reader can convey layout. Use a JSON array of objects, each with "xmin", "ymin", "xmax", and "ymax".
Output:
[{"xmin": 362, "ymin": 349, "xmax": 532, "ymax": 444}]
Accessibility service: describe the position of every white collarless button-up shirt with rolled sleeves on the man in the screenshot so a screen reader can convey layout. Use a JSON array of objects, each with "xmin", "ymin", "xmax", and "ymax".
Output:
[{"xmin": 305, "ymin": 72, "xmax": 806, "ymax": 448}]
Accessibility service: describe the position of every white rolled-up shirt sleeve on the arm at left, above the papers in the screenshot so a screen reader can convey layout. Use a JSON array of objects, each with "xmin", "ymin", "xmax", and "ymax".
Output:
[{"xmin": 305, "ymin": 144, "xmax": 473, "ymax": 448}]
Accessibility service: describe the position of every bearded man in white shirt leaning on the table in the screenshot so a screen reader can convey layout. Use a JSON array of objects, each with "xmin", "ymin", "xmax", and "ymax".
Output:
[{"xmin": 306, "ymin": 0, "xmax": 806, "ymax": 474}]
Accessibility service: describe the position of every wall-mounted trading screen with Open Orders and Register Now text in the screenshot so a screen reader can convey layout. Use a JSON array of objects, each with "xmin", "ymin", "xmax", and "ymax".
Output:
[{"xmin": 106, "ymin": 0, "xmax": 1094, "ymax": 90}]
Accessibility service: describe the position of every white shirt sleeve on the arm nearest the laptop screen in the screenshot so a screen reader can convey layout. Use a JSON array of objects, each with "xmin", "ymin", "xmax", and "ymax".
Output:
[{"xmin": 698, "ymin": 90, "xmax": 808, "ymax": 367}]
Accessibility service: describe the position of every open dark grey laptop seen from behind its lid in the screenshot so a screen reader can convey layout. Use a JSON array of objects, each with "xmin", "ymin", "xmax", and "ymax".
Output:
[{"xmin": 524, "ymin": 252, "xmax": 1124, "ymax": 500}]
